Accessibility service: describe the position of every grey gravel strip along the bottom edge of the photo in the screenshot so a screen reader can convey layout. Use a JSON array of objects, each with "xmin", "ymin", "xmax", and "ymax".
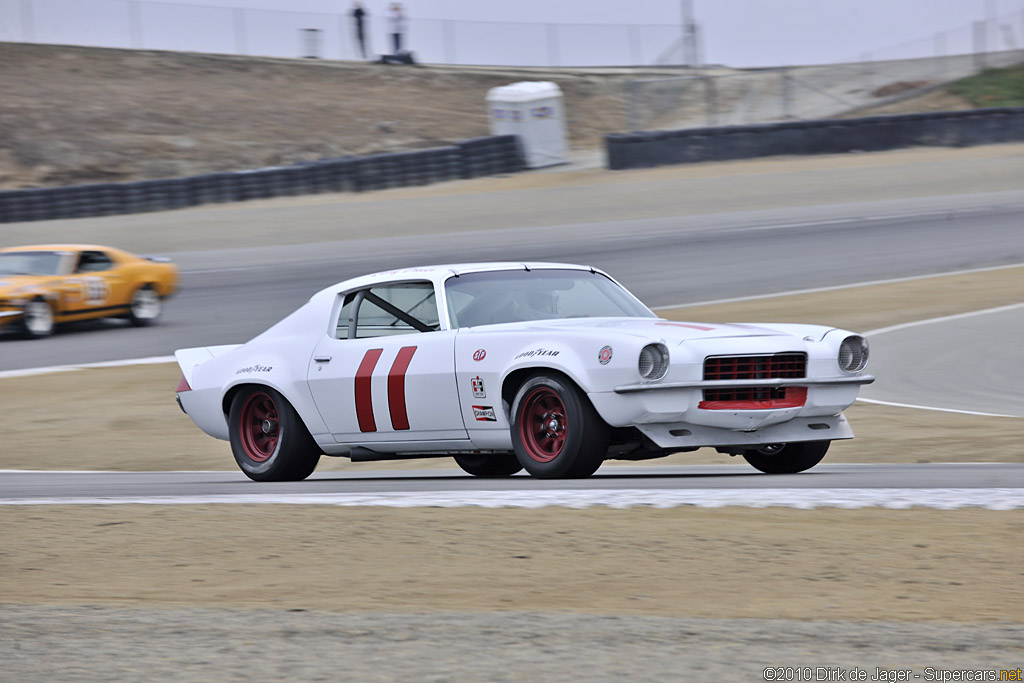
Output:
[{"xmin": 0, "ymin": 605, "xmax": 1024, "ymax": 683}]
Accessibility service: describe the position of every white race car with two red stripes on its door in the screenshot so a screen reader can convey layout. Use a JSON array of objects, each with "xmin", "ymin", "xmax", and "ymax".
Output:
[{"xmin": 175, "ymin": 263, "xmax": 873, "ymax": 481}]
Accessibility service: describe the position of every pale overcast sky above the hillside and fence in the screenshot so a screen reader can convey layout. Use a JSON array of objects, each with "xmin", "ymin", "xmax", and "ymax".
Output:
[{"xmin": 8, "ymin": 0, "xmax": 1024, "ymax": 67}]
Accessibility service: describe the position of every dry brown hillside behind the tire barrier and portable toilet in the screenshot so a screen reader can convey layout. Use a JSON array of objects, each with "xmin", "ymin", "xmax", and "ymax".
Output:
[{"xmin": 0, "ymin": 43, "xmax": 1007, "ymax": 189}]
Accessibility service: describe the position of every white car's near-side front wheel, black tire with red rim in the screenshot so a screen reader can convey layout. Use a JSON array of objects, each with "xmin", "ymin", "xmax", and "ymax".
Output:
[{"xmin": 511, "ymin": 375, "xmax": 609, "ymax": 479}]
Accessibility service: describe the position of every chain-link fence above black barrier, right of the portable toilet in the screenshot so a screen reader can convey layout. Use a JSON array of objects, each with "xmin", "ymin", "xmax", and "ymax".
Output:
[{"xmin": 626, "ymin": 11, "xmax": 1024, "ymax": 131}]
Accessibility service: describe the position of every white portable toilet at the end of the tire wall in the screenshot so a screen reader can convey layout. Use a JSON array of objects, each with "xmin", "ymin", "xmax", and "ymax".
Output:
[{"xmin": 487, "ymin": 81, "xmax": 568, "ymax": 168}]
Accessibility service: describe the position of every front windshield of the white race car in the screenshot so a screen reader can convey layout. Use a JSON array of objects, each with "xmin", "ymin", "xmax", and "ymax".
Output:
[{"xmin": 444, "ymin": 269, "xmax": 656, "ymax": 329}]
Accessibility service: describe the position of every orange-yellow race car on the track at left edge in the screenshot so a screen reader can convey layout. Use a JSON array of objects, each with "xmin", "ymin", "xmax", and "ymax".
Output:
[{"xmin": 0, "ymin": 245, "xmax": 178, "ymax": 337}]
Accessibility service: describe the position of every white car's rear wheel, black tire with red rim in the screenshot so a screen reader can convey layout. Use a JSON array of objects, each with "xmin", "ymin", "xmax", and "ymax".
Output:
[{"xmin": 227, "ymin": 386, "xmax": 321, "ymax": 481}]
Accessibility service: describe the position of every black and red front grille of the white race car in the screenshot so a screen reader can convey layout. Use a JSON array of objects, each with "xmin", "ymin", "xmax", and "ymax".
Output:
[{"xmin": 699, "ymin": 353, "xmax": 807, "ymax": 410}]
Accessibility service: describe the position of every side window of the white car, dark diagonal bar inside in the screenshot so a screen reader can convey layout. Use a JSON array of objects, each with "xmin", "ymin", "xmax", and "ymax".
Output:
[{"xmin": 336, "ymin": 283, "xmax": 440, "ymax": 339}]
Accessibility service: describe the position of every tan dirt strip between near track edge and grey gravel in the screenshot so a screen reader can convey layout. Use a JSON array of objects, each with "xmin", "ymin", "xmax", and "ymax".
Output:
[{"xmin": 0, "ymin": 505, "xmax": 1024, "ymax": 623}]
